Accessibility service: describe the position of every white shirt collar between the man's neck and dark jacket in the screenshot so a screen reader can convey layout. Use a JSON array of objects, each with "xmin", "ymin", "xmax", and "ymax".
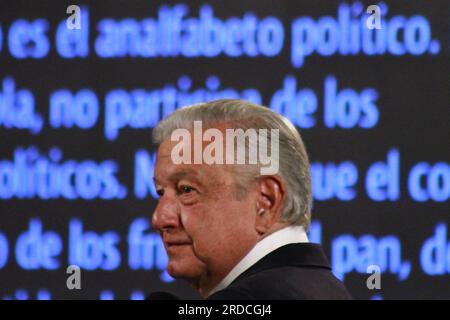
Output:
[{"xmin": 208, "ymin": 226, "xmax": 309, "ymax": 295}]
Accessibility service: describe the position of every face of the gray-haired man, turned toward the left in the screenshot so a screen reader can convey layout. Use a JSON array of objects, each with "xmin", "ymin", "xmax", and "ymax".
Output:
[{"xmin": 153, "ymin": 139, "xmax": 258, "ymax": 289}]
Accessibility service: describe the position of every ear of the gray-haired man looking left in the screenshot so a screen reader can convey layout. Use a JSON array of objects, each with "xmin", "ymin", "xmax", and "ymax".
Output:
[{"xmin": 255, "ymin": 176, "xmax": 286, "ymax": 235}]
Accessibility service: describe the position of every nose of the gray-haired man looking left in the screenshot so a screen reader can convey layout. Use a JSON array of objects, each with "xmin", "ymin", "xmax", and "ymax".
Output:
[{"xmin": 152, "ymin": 197, "xmax": 180, "ymax": 232}]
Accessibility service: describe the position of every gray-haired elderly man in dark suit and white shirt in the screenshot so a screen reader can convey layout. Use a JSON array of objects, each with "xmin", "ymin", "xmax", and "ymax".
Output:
[{"xmin": 153, "ymin": 100, "xmax": 350, "ymax": 299}]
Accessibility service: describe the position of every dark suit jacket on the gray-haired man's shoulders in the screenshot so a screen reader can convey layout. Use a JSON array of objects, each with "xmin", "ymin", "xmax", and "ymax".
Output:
[{"xmin": 208, "ymin": 243, "xmax": 351, "ymax": 300}]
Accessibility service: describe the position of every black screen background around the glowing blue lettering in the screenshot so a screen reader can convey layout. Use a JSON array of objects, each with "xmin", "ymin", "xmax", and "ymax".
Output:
[{"xmin": 0, "ymin": 1, "xmax": 450, "ymax": 299}]
